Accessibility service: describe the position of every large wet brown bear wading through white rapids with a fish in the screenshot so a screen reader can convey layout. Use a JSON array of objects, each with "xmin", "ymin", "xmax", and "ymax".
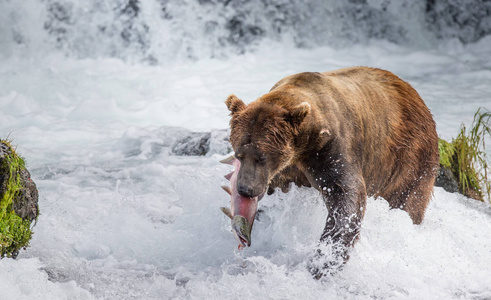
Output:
[{"xmin": 225, "ymin": 67, "xmax": 439, "ymax": 277}]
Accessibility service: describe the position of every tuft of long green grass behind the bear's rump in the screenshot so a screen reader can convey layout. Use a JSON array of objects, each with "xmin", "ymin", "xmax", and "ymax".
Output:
[{"xmin": 438, "ymin": 108, "xmax": 491, "ymax": 201}]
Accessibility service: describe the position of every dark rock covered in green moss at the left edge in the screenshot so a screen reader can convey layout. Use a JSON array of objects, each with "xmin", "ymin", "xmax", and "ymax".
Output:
[{"xmin": 0, "ymin": 140, "xmax": 39, "ymax": 258}]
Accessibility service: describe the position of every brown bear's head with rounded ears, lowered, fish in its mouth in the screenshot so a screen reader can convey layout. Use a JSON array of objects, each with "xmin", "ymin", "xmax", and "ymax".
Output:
[{"xmin": 225, "ymin": 95, "xmax": 310, "ymax": 198}]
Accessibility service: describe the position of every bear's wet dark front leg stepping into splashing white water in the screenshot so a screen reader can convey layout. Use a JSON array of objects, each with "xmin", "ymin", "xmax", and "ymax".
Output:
[{"xmin": 309, "ymin": 169, "xmax": 367, "ymax": 279}]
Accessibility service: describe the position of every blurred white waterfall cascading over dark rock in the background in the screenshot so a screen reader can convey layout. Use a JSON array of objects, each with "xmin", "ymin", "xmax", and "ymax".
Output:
[{"xmin": 0, "ymin": 0, "xmax": 491, "ymax": 64}]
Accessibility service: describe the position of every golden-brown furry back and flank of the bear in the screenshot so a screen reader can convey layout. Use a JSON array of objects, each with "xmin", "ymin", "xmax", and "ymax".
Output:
[{"xmin": 271, "ymin": 67, "xmax": 438, "ymax": 197}]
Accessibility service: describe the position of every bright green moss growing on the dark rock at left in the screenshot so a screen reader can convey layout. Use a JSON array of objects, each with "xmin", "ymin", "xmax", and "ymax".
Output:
[{"xmin": 0, "ymin": 140, "xmax": 32, "ymax": 257}]
